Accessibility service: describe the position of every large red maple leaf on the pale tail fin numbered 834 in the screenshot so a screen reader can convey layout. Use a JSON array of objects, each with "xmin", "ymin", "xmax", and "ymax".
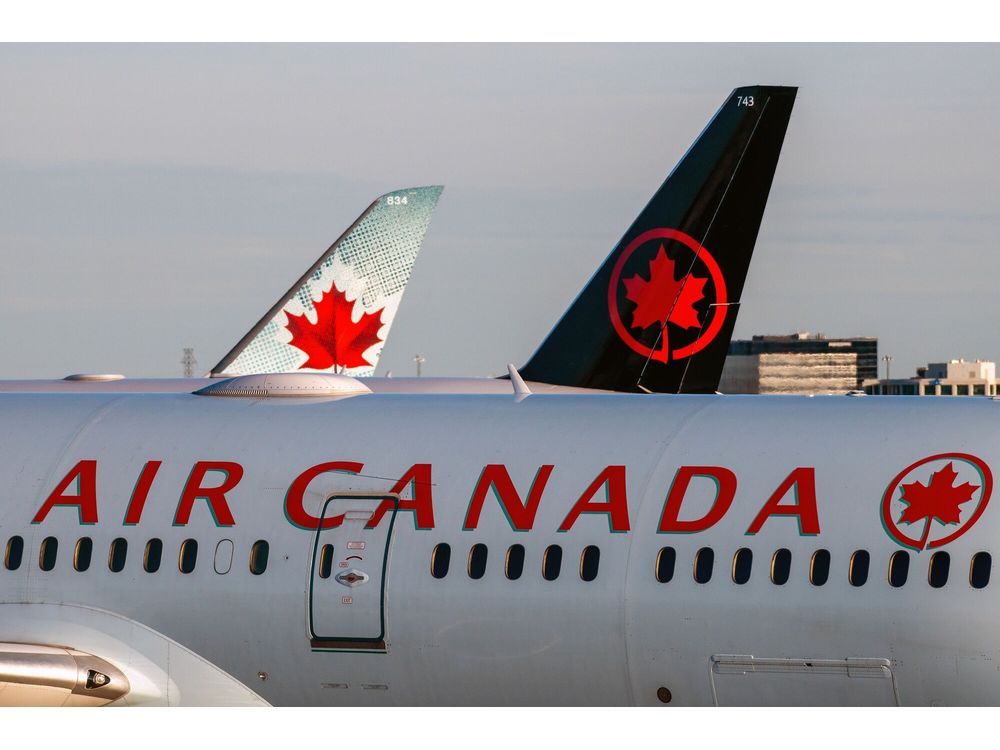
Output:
[{"xmin": 288, "ymin": 283, "xmax": 384, "ymax": 370}]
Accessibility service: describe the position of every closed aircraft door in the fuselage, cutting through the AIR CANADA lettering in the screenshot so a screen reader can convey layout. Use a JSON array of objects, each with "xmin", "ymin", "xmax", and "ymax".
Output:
[{"xmin": 308, "ymin": 495, "xmax": 399, "ymax": 651}]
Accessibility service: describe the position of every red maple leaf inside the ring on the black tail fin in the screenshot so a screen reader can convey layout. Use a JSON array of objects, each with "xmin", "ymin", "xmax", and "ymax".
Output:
[{"xmin": 622, "ymin": 244, "xmax": 708, "ymax": 328}]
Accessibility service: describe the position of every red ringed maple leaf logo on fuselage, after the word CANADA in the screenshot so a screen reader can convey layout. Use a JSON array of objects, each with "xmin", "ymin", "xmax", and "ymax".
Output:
[{"xmin": 881, "ymin": 453, "xmax": 993, "ymax": 552}]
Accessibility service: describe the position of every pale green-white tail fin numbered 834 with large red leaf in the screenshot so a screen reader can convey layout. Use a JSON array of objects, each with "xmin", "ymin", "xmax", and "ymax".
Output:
[{"xmin": 212, "ymin": 185, "xmax": 444, "ymax": 376}]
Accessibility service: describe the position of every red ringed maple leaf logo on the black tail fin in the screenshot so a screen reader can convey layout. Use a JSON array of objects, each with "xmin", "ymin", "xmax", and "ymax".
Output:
[{"xmin": 608, "ymin": 228, "xmax": 728, "ymax": 362}]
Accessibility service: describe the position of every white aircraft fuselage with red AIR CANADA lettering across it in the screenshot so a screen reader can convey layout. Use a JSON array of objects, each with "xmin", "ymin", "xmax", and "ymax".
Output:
[{"xmin": 0, "ymin": 393, "xmax": 1000, "ymax": 706}]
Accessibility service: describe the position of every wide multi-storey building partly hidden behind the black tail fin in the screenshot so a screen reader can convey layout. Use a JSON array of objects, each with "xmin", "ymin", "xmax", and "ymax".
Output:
[{"xmin": 719, "ymin": 332, "xmax": 878, "ymax": 394}]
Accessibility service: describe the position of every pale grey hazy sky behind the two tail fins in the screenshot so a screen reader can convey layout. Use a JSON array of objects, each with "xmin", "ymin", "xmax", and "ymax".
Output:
[{"xmin": 0, "ymin": 45, "xmax": 1000, "ymax": 377}]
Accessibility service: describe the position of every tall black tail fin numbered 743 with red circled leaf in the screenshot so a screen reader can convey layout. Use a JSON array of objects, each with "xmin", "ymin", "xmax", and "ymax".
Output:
[{"xmin": 521, "ymin": 86, "xmax": 797, "ymax": 393}]
